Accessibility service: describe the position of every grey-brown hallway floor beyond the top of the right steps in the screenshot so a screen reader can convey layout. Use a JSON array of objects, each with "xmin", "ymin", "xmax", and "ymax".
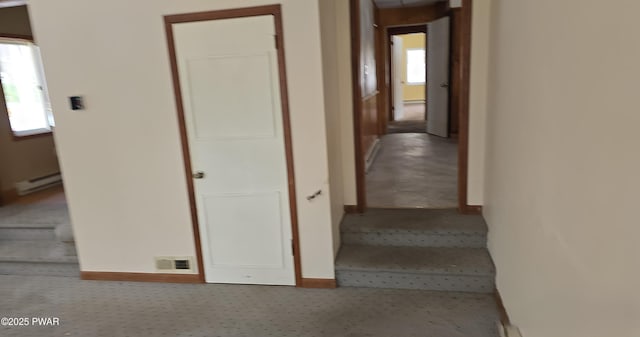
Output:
[{"xmin": 366, "ymin": 133, "xmax": 458, "ymax": 208}]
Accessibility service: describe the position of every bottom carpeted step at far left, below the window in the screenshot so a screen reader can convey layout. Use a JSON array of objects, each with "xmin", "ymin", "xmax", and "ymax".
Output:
[{"xmin": 0, "ymin": 240, "xmax": 80, "ymax": 277}]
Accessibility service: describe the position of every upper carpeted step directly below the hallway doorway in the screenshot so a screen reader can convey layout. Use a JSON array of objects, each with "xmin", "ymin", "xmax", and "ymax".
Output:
[{"xmin": 341, "ymin": 209, "xmax": 487, "ymax": 248}]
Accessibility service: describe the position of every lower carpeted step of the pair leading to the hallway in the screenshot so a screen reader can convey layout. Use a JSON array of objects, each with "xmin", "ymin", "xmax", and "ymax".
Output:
[{"xmin": 336, "ymin": 244, "xmax": 495, "ymax": 293}]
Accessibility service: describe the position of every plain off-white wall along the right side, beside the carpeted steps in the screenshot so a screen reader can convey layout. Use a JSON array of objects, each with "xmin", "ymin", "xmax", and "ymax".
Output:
[{"xmin": 484, "ymin": 0, "xmax": 640, "ymax": 337}]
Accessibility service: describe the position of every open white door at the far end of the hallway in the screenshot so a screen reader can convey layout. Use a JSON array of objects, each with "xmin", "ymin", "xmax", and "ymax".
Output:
[{"xmin": 427, "ymin": 17, "xmax": 449, "ymax": 137}]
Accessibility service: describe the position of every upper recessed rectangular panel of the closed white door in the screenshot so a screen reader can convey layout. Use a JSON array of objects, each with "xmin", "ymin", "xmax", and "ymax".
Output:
[{"xmin": 187, "ymin": 53, "xmax": 276, "ymax": 140}]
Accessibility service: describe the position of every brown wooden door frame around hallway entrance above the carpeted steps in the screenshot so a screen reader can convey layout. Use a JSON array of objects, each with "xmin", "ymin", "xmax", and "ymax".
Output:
[{"xmin": 350, "ymin": 0, "xmax": 482, "ymax": 214}]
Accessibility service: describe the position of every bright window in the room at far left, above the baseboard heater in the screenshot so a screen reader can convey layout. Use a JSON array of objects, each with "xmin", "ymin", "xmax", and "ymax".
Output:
[{"xmin": 0, "ymin": 38, "xmax": 54, "ymax": 137}]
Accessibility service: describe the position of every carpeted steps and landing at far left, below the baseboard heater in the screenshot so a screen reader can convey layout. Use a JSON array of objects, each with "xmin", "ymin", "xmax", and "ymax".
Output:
[{"xmin": 0, "ymin": 204, "xmax": 80, "ymax": 277}]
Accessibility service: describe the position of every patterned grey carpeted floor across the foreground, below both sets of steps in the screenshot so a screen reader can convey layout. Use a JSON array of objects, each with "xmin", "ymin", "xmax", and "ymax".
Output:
[{"xmin": 0, "ymin": 276, "xmax": 498, "ymax": 337}]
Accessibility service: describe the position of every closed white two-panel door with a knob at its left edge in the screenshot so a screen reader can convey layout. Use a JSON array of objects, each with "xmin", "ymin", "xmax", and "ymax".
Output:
[{"xmin": 173, "ymin": 15, "xmax": 295, "ymax": 285}]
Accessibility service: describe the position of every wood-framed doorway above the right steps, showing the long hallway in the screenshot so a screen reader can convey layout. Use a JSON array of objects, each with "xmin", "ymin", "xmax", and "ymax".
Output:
[{"xmin": 351, "ymin": 0, "xmax": 479, "ymax": 213}]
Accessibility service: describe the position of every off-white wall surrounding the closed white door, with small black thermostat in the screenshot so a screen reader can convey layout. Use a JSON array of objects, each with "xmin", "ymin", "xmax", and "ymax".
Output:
[{"xmin": 30, "ymin": 0, "xmax": 334, "ymax": 278}]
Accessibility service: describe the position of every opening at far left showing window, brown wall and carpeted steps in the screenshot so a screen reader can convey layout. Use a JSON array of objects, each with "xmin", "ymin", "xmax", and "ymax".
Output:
[{"xmin": 0, "ymin": 1, "xmax": 79, "ymax": 277}]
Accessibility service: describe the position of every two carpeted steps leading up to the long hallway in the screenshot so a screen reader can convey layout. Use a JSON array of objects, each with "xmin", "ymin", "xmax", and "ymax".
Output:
[{"xmin": 336, "ymin": 209, "xmax": 495, "ymax": 293}]
